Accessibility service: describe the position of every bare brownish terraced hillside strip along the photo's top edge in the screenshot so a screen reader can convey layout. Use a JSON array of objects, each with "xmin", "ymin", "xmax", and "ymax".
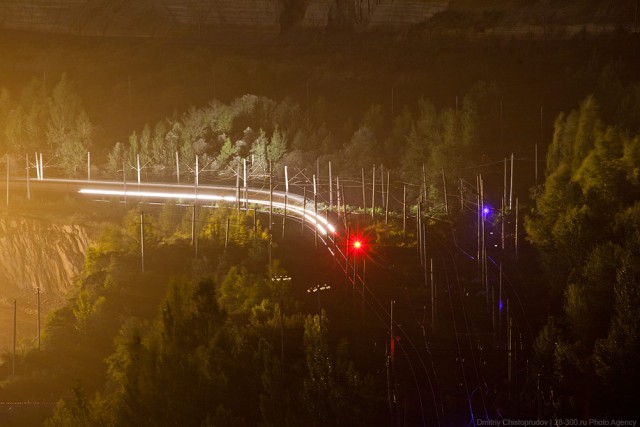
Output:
[{"xmin": 0, "ymin": 0, "xmax": 637, "ymax": 41}]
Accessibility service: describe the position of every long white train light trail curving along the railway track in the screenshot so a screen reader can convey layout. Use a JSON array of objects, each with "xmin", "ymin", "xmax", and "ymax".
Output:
[{"xmin": 78, "ymin": 188, "xmax": 336, "ymax": 235}]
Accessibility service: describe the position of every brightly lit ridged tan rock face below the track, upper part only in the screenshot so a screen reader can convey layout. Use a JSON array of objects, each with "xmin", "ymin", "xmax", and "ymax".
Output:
[{"xmin": 0, "ymin": 216, "xmax": 89, "ymax": 296}]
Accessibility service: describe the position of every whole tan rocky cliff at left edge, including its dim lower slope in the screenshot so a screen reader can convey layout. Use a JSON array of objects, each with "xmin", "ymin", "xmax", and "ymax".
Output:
[{"xmin": 0, "ymin": 215, "xmax": 89, "ymax": 352}]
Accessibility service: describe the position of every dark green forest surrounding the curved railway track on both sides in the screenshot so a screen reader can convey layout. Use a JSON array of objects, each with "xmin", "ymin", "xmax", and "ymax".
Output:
[{"xmin": 0, "ymin": 25, "xmax": 640, "ymax": 426}]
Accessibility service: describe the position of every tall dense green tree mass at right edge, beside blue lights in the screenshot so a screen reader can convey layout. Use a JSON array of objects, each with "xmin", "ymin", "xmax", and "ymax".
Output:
[{"xmin": 525, "ymin": 97, "xmax": 640, "ymax": 415}]
